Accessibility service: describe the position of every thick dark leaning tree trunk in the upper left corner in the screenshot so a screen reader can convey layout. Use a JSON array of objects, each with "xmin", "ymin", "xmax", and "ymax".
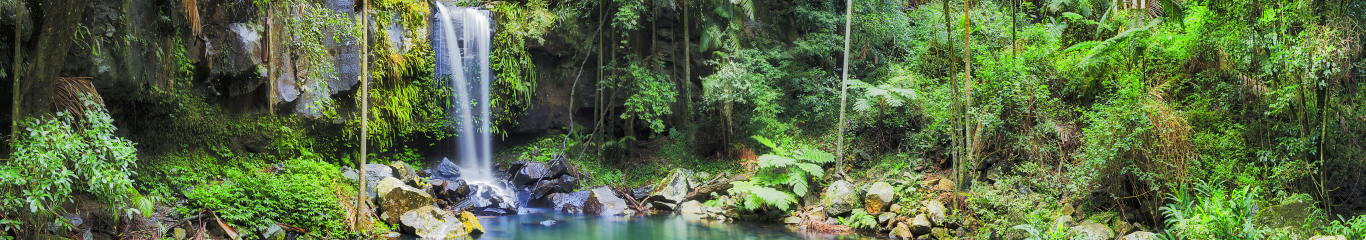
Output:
[{"xmin": 15, "ymin": 0, "xmax": 86, "ymax": 119}]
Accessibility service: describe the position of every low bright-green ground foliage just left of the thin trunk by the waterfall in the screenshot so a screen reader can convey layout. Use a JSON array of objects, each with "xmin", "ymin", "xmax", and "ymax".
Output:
[{"xmin": 180, "ymin": 158, "xmax": 355, "ymax": 237}]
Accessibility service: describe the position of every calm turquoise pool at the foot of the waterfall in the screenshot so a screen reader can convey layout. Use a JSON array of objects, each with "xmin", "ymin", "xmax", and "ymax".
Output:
[{"xmin": 479, "ymin": 210, "xmax": 867, "ymax": 240}]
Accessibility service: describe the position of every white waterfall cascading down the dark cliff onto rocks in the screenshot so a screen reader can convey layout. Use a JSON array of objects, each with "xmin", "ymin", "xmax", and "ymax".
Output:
[{"xmin": 433, "ymin": 1, "xmax": 516, "ymax": 214}]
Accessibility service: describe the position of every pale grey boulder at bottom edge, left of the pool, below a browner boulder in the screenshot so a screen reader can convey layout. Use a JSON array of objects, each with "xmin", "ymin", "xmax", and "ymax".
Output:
[{"xmin": 399, "ymin": 206, "xmax": 470, "ymax": 239}]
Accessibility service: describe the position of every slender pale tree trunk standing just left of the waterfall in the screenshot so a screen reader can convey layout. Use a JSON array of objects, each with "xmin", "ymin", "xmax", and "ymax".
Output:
[{"xmin": 351, "ymin": 0, "xmax": 371, "ymax": 230}]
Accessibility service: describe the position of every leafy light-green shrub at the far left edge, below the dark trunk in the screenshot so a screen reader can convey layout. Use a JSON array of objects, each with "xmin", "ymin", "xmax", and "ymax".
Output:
[{"xmin": 0, "ymin": 97, "xmax": 140, "ymax": 222}]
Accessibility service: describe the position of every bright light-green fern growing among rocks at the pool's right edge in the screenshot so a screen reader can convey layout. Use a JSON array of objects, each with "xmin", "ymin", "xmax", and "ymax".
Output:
[{"xmin": 729, "ymin": 135, "xmax": 835, "ymax": 211}]
